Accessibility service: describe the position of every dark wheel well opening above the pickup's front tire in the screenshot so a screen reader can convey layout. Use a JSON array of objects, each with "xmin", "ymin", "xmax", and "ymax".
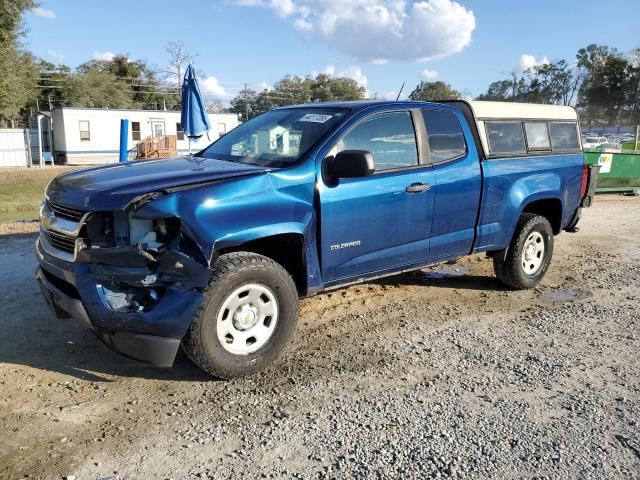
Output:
[{"xmin": 218, "ymin": 233, "xmax": 307, "ymax": 295}]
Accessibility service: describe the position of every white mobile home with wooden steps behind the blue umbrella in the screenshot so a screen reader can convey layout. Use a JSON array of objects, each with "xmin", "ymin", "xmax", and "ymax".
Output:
[{"xmin": 52, "ymin": 107, "xmax": 239, "ymax": 164}]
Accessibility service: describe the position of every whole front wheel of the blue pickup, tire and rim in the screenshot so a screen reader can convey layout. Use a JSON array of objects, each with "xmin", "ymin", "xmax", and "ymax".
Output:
[{"xmin": 182, "ymin": 252, "xmax": 298, "ymax": 378}]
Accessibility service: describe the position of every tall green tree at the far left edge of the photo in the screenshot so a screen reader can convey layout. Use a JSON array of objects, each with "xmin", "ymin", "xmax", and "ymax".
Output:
[{"xmin": 0, "ymin": 0, "xmax": 37, "ymax": 126}]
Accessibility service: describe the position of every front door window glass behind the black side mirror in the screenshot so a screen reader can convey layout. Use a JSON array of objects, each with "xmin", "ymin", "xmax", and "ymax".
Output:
[{"xmin": 336, "ymin": 112, "xmax": 418, "ymax": 171}]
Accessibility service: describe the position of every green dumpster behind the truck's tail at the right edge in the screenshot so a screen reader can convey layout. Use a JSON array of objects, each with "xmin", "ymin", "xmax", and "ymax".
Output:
[{"xmin": 584, "ymin": 149, "xmax": 640, "ymax": 193}]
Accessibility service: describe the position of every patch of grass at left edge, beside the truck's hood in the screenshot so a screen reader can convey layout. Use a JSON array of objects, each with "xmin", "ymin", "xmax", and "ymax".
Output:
[{"xmin": 0, "ymin": 167, "xmax": 78, "ymax": 227}]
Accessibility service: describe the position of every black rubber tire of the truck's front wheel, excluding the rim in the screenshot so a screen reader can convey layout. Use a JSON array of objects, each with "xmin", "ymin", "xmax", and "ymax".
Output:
[{"xmin": 182, "ymin": 252, "xmax": 298, "ymax": 379}]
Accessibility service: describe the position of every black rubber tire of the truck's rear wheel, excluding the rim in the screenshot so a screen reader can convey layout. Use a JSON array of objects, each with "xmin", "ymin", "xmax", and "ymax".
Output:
[{"xmin": 493, "ymin": 213, "xmax": 553, "ymax": 290}]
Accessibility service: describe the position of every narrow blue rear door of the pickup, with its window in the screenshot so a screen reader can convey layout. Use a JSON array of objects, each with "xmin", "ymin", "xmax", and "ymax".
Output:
[{"xmin": 422, "ymin": 107, "xmax": 482, "ymax": 260}]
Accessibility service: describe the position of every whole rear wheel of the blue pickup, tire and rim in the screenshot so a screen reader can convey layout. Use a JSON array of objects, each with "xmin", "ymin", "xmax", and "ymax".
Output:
[{"xmin": 493, "ymin": 213, "xmax": 553, "ymax": 290}]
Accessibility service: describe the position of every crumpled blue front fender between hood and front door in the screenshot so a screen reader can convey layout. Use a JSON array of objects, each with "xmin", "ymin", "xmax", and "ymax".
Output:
[{"xmin": 136, "ymin": 162, "xmax": 320, "ymax": 286}]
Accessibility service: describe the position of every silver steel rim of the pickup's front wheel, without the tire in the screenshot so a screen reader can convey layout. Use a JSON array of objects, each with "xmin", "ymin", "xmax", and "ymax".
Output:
[{"xmin": 216, "ymin": 283, "xmax": 278, "ymax": 355}]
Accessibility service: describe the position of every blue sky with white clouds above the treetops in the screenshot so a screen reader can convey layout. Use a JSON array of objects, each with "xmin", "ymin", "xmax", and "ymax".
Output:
[{"xmin": 25, "ymin": 0, "xmax": 640, "ymax": 100}]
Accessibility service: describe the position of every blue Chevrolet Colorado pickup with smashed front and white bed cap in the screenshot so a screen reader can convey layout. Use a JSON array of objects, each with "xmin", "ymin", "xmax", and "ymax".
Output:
[{"xmin": 36, "ymin": 101, "xmax": 597, "ymax": 378}]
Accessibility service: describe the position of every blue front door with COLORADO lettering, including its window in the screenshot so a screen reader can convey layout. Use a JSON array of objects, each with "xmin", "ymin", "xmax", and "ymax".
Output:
[{"xmin": 319, "ymin": 110, "xmax": 433, "ymax": 284}]
